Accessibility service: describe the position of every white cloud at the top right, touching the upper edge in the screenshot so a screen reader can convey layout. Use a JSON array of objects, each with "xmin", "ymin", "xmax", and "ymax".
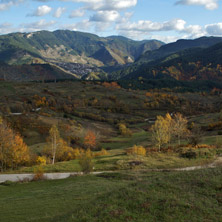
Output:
[{"xmin": 176, "ymin": 0, "xmax": 218, "ymax": 10}]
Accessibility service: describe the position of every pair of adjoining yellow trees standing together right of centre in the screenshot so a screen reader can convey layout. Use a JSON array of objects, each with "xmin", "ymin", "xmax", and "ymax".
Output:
[{"xmin": 151, "ymin": 113, "xmax": 189, "ymax": 151}]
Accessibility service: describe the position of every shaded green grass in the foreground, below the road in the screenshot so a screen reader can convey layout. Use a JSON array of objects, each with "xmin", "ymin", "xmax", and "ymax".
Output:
[{"xmin": 0, "ymin": 168, "xmax": 222, "ymax": 222}]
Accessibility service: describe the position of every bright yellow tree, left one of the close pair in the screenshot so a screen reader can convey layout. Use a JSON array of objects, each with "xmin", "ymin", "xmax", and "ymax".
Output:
[{"xmin": 151, "ymin": 116, "xmax": 170, "ymax": 151}]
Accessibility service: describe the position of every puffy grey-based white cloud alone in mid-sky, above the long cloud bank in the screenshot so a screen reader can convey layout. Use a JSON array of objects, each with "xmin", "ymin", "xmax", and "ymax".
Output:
[{"xmin": 90, "ymin": 11, "xmax": 120, "ymax": 22}]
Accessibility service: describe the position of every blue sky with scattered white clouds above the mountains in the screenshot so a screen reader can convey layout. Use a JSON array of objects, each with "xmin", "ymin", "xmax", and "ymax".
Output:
[{"xmin": 0, "ymin": 0, "xmax": 222, "ymax": 42}]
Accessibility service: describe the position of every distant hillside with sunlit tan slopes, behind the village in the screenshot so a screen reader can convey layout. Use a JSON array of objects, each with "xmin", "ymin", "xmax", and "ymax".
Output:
[{"xmin": 0, "ymin": 30, "xmax": 163, "ymax": 67}]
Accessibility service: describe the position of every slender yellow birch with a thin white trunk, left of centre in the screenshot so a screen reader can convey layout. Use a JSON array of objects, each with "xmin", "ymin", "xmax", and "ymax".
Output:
[{"xmin": 49, "ymin": 125, "xmax": 60, "ymax": 164}]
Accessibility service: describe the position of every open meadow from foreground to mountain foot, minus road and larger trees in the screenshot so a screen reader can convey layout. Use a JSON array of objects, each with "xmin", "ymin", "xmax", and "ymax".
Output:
[{"xmin": 0, "ymin": 81, "xmax": 222, "ymax": 222}]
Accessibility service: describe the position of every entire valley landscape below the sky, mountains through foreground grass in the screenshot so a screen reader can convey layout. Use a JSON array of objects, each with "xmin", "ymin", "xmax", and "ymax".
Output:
[{"xmin": 0, "ymin": 30, "xmax": 222, "ymax": 222}]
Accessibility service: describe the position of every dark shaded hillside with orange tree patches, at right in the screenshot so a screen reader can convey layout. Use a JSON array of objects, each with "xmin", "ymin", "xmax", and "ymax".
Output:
[{"xmin": 113, "ymin": 40, "xmax": 222, "ymax": 81}]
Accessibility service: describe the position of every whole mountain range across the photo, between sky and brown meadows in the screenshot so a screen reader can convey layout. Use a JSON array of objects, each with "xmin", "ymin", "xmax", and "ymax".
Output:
[{"xmin": 0, "ymin": 30, "xmax": 222, "ymax": 81}]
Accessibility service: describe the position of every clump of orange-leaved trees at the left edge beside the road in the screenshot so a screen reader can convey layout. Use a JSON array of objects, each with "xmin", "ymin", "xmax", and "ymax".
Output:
[{"xmin": 0, "ymin": 117, "xmax": 30, "ymax": 172}]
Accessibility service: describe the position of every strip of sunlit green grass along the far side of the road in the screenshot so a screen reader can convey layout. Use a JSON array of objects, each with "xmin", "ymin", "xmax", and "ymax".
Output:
[{"xmin": 11, "ymin": 149, "xmax": 218, "ymax": 173}]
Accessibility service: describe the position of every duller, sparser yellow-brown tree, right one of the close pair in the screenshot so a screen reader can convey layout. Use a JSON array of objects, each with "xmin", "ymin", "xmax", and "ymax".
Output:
[{"xmin": 172, "ymin": 113, "xmax": 188, "ymax": 145}]
